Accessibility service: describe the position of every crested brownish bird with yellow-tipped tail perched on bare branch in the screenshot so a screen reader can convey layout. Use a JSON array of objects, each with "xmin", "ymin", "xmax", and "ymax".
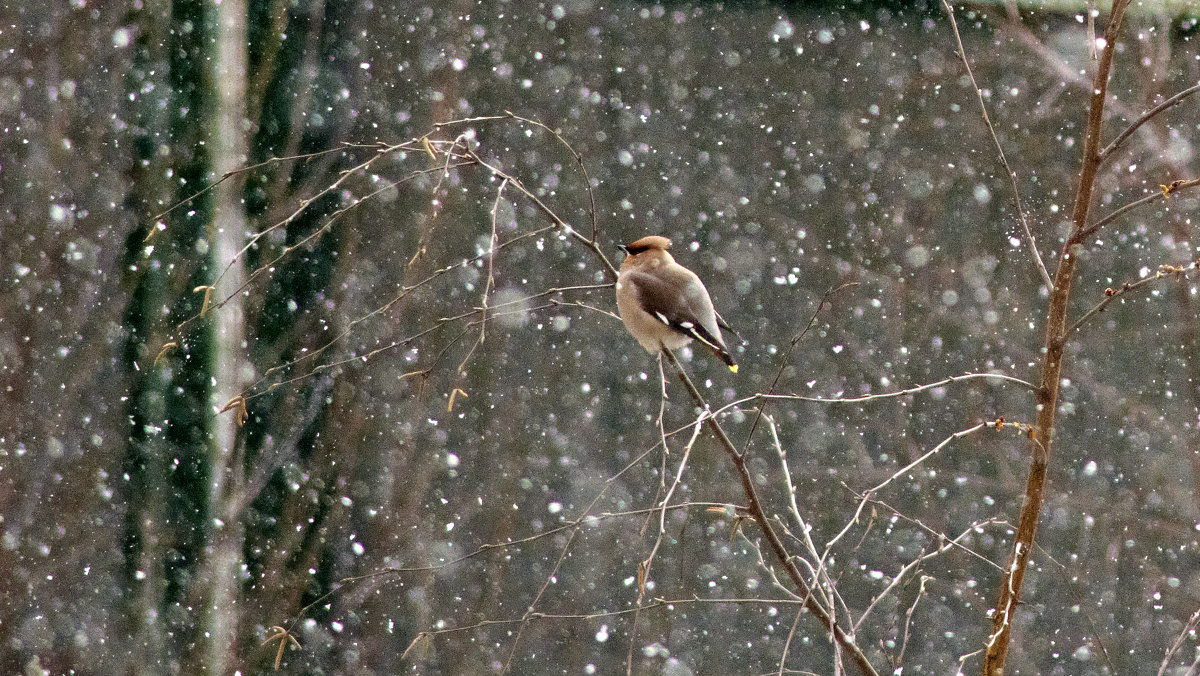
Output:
[{"xmin": 617, "ymin": 235, "xmax": 738, "ymax": 373}]
